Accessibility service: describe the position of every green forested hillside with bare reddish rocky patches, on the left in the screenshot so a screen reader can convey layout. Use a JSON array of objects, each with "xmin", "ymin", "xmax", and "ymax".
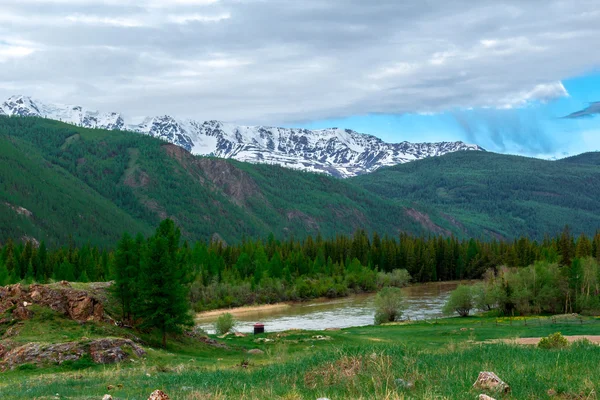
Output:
[{"xmin": 0, "ymin": 117, "xmax": 426, "ymax": 245}]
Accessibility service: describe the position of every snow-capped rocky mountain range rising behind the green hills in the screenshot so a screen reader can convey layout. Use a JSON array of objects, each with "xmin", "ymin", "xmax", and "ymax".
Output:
[{"xmin": 0, "ymin": 96, "xmax": 483, "ymax": 178}]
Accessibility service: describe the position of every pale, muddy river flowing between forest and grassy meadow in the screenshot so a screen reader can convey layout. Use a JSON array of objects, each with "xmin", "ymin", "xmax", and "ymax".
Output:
[{"xmin": 196, "ymin": 282, "xmax": 459, "ymax": 333}]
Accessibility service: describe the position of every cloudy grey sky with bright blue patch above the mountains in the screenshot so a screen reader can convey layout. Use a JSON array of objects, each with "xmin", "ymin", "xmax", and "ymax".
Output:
[{"xmin": 0, "ymin": 0, "xmax": 600, "ymax": 157}]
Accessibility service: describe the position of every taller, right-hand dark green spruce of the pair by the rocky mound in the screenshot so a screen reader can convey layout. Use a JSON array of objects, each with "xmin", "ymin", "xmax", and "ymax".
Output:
[{"xmin": 138, "ymin": 219, "xmax": 193, "ymax": 347}]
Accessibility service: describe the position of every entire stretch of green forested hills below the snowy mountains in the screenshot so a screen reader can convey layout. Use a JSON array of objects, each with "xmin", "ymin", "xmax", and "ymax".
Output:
[{"xmin": 0, "ymin": 117, "xmax": 600, "ymax": 245}]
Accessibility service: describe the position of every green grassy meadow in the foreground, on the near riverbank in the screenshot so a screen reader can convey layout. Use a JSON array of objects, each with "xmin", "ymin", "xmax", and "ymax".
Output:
[{"xmin": 0, "ymin": 317, "xmax": 600, "ymax": 400}]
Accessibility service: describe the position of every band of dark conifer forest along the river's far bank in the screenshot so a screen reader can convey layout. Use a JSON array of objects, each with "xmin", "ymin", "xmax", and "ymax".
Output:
[{"xmin": 0, "ymin": 220, "xmax": 600, "ymax": 311}]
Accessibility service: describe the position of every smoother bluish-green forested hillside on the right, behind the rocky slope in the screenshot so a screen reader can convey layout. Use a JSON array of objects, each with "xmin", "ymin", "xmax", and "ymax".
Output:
[{"xmin": 351, "ymin": 152, "xmax": 600, "ymax": 239}]
